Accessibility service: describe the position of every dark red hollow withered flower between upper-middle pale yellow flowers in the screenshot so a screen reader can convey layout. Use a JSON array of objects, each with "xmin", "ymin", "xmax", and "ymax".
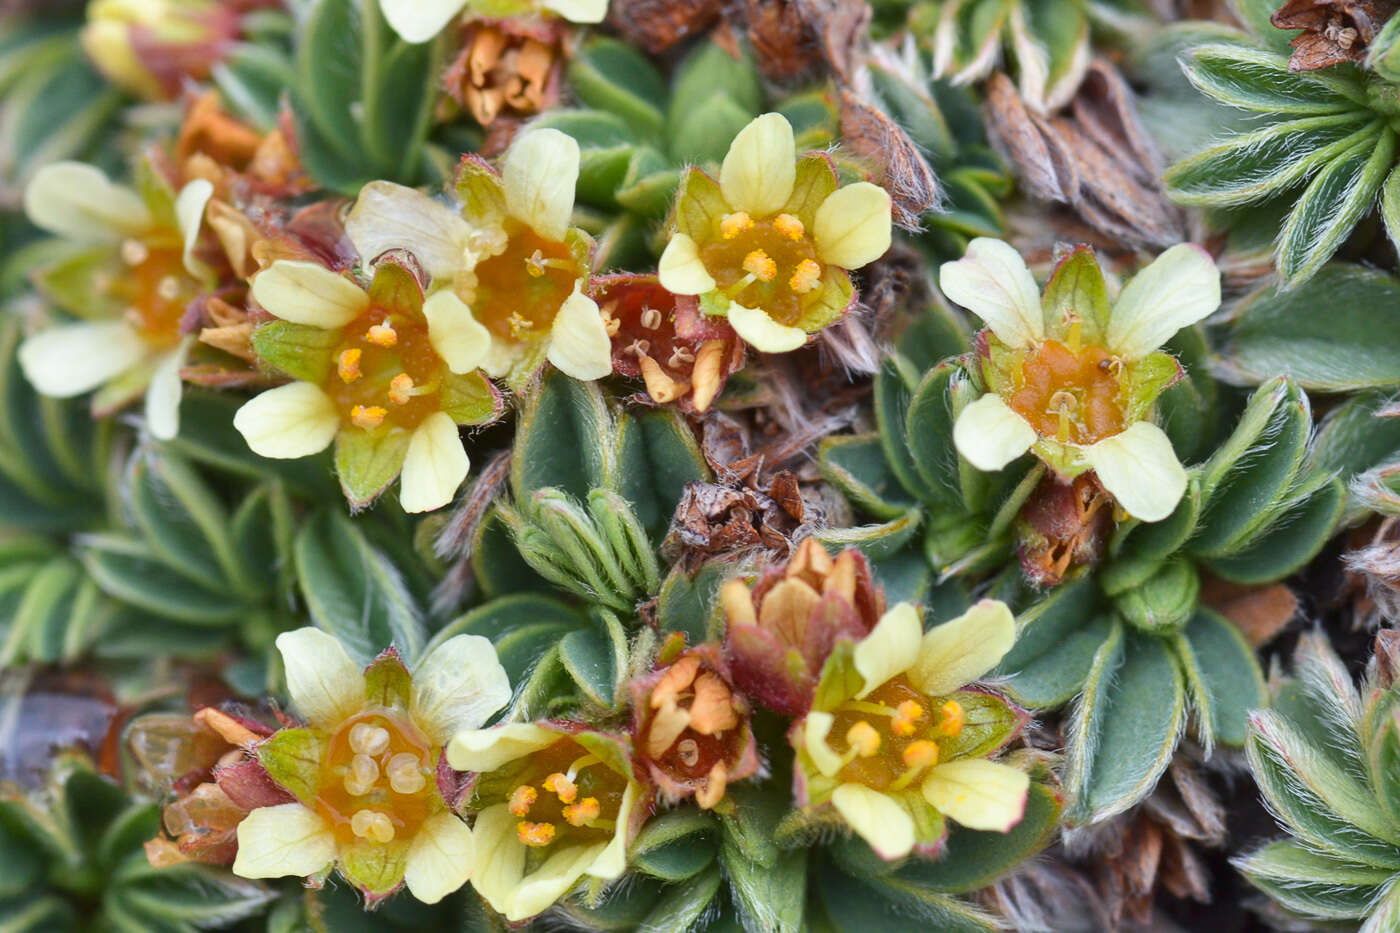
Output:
[{"xmin": 592, "ymin": 275, "xmax": 743, "ymax": 412}]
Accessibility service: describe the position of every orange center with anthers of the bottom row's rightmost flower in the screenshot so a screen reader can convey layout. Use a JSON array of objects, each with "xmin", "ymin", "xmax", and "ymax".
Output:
[{"xmin": 827, "ymin": 677, "xmax": 963, "ymax": 792}]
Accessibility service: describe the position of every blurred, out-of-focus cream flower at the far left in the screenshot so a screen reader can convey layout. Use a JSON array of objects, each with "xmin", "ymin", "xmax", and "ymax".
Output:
[{"xmin": 20, "ymin": 163, "xmax": 214, "ymax": 440}]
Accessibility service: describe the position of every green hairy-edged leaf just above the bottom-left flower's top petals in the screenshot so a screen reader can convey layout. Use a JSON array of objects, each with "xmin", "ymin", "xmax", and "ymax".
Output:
[{"xmin": 293, "ymin": 510, "xmax": 424, "ymax": 664}]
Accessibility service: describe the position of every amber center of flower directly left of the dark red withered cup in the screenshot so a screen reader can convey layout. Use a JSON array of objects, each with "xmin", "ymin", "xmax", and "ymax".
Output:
[{"xmin": 469, "ymin": 219, "xmax": 587, "ymax": 340}]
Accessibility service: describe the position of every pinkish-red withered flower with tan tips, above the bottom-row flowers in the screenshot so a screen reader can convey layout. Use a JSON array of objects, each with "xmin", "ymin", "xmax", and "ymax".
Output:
[{"xmin": 720, "ymin": 538, "xmax": 885, "ymax": 716}]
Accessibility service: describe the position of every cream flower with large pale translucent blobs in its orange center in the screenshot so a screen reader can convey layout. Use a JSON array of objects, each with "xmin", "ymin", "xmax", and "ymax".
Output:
[{"xmin": 234, "ymin": 628, "xmax": 511, "ymax": 904}]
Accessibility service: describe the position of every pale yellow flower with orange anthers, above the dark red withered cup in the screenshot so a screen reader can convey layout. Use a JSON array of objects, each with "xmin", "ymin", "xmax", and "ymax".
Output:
[{"xmin": 658, "ymin": 113, "xmax": 892, "ymax": 353}]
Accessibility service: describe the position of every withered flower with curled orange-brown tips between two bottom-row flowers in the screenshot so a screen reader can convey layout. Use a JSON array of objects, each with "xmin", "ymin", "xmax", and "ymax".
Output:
[{"xmin": 631, "ymin": 644, "xmax": 759, "ymax": 810}]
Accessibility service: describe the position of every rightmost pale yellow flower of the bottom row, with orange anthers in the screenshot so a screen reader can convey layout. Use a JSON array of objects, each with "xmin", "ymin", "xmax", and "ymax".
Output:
[{"xmin": 790, "ymin": 600, "xmax": 1029, "ymax": 859}]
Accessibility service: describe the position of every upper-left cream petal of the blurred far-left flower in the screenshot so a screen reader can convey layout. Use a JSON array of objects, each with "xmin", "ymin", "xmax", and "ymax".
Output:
[{"xmin": 24, "ymin": 163, "xmax": 153, "ymax": 241}]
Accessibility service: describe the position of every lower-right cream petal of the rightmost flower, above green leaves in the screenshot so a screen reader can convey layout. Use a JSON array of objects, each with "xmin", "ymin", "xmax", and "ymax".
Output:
[{"xmin": 1084, "ymin": 422, "xmax": 1186, "ymax": 521}]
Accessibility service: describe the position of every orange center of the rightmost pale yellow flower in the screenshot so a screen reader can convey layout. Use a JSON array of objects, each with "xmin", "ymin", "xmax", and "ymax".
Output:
[{"xmin": 1007, "ymin": 340, "xmax": 1124, "ymax": 444}]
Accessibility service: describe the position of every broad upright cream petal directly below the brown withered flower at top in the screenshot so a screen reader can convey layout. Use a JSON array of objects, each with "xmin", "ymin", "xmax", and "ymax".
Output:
[{"xmin": 501, "ymin": 129, "xmax": 578, "ymax": 241}]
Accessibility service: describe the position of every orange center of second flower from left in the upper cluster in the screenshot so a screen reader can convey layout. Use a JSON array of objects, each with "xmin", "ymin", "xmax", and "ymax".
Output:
[{"xmin": 326, "ymin": 307, "xmax": 442, "ymax": 430}]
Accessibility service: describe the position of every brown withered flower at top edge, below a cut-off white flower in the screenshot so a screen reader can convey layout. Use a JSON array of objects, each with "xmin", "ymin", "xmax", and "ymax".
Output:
[{"xmin": 442, "ymin": 17, "xmax": 568, "ymax": 126}]
